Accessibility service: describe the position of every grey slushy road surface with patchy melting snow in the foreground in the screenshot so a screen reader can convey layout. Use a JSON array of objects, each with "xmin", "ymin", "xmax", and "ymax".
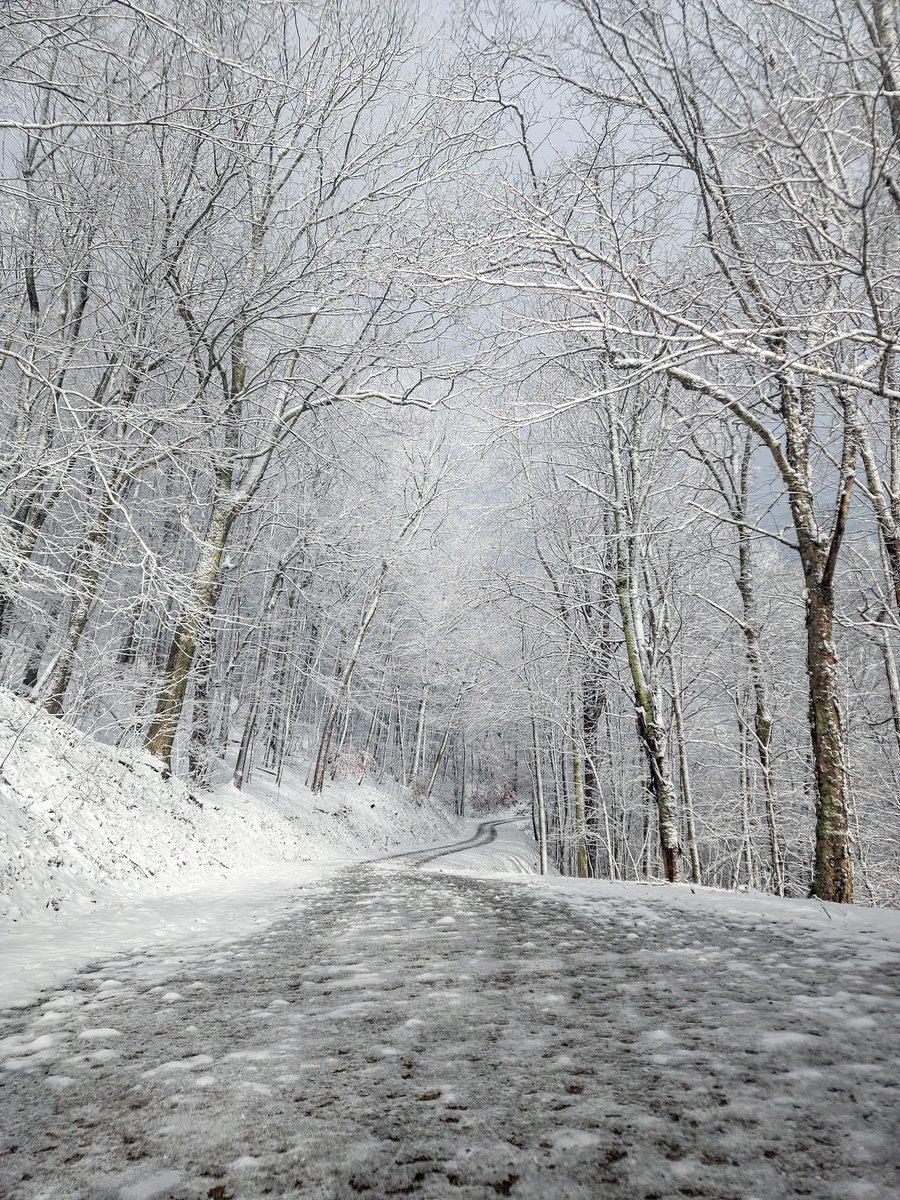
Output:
[{"xmin": 0, "ymin": 830, "xmax": 900, "ymax": 1200}]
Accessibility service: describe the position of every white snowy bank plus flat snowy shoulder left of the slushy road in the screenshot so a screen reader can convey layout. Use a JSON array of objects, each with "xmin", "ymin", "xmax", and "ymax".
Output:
[{"xmin": 0, "ymin": 689, "xmax": 468, "ymax": 1007}]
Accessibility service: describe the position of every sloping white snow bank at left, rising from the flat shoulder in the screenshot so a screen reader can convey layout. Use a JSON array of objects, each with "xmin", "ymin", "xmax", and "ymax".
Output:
[{"xmin": 0, "ymin": 690, "xmax": 460, "ymax": 923}]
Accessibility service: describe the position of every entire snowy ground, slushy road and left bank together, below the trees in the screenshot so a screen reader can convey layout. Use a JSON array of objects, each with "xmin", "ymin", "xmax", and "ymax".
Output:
[{"xmin": 0, "ymin": 696, "xmax": 900, "ymax": 1200}]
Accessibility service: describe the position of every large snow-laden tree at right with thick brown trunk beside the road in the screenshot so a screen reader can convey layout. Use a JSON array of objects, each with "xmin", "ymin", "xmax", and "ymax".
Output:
[{"xmin": 460, "ymin": 0, "xmax": 900, "ymax": 900}]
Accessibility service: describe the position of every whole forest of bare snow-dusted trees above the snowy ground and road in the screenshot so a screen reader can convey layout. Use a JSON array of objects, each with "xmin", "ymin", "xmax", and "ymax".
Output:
[{"xmin": 0, "ymin": 0, "xmax": 900, "ymax": 906}]
